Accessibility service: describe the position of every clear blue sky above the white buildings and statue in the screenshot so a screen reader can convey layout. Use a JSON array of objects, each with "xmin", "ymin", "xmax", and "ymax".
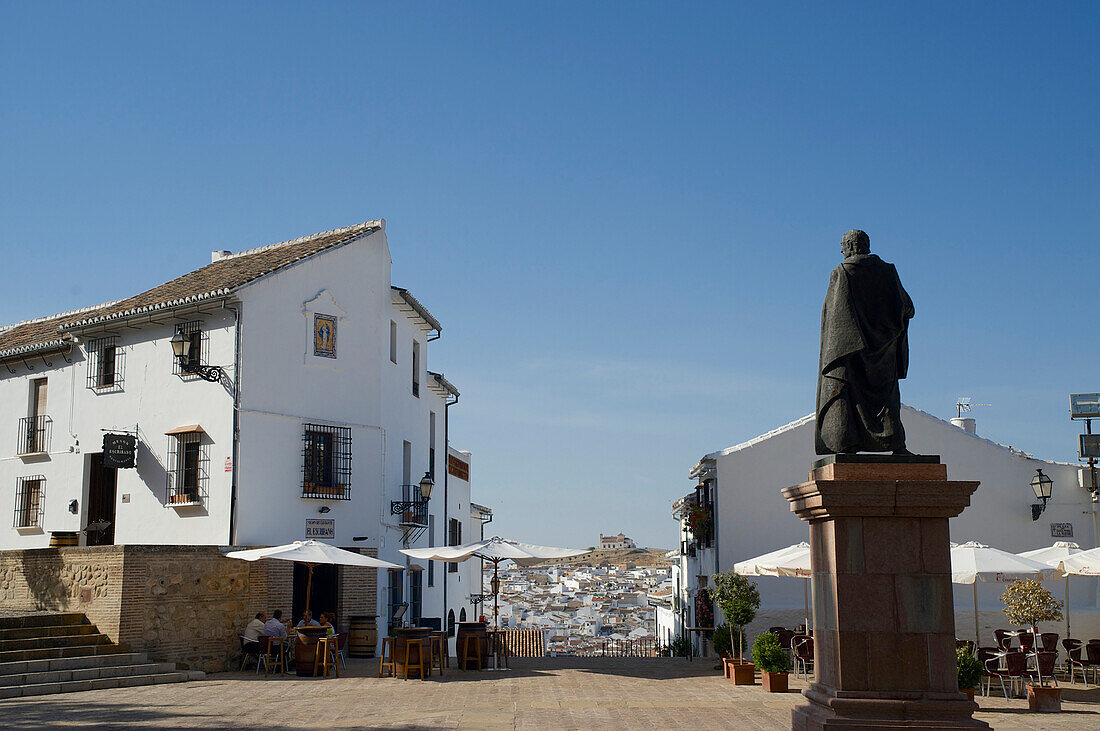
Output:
[{"xmin": 0, "ymin": 2, "xmax": 1100, "ymax": 546}]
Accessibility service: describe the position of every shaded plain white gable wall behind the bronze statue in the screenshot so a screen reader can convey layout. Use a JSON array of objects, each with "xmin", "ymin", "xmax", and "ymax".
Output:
[{"xmin": 689, "ymin": 407, "xmax": 1100, "ymax": 638}]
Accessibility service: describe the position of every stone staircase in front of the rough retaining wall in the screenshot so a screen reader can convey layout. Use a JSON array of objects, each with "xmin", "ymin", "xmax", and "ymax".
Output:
[{"xmin": 0, "ymin": 613, "xmax": 206, "ymax": 698}]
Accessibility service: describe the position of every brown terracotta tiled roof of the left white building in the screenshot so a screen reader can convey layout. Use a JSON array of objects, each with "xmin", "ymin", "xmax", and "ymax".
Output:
[{"xmin": 0, "ymin": 221, "xmax": 385, "ymax": 358}]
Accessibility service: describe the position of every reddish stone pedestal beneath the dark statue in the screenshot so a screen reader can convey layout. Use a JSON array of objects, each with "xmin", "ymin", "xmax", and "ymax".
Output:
[{"xmin": 783, "ymin": 455, "xmax": 989, "ymax": 731}]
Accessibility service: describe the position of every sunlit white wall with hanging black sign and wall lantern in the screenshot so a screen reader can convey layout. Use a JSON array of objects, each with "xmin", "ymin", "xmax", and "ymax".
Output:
[{"xmin": 0, "ymin": 310, "xmax": 235, "ymax": 549}]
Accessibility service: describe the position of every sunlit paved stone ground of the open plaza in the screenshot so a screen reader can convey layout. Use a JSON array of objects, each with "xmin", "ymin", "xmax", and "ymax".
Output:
[{"xmin": 0, "ymin": 657, "xmax": 1100, "ymax": 730}]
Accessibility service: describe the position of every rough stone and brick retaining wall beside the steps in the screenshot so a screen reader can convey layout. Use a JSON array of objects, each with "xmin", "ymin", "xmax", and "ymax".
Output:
[{"xmin": 0, "ymin": 545, "xmax": 377, "ymax": 673}]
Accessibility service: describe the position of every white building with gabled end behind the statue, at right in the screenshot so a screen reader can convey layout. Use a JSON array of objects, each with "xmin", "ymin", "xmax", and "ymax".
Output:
[{"xmin": 658, "ymin": 406, "xmax": 1100, "ymax": 643}]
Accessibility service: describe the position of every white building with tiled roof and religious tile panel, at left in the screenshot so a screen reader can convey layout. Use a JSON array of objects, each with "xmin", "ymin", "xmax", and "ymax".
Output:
[{"xmin": 0, "ymin": 220, "xmax": 492, "ymax": 631}]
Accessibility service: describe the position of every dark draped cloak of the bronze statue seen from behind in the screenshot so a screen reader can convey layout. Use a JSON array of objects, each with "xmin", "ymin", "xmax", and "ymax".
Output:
[{"xmin": 814, "ymin": 254, "xmax": 913, "ymax": 454}]
